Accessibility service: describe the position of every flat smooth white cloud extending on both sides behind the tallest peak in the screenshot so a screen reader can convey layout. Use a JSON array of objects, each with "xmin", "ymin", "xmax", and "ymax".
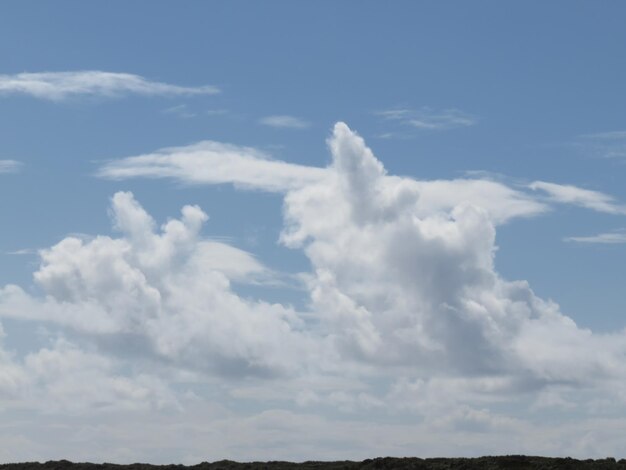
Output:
[{"xmin": 97, "ymin": 141, "xmax": 549, "ymax": 223}]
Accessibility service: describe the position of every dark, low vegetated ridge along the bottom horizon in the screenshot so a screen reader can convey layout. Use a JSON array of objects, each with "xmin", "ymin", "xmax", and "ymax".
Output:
[{"xmin": 0, "ymin": 455, "xmax": 626, "ymax": 470}]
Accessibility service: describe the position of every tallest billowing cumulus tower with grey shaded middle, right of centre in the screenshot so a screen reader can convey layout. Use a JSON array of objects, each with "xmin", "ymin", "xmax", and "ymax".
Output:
[{"xmin": 282, "ymin": 123, "xmax": 626, "ymax": 384}]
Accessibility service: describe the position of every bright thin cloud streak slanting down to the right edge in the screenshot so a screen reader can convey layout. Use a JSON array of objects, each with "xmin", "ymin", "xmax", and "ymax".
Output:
[{"xmin": 528, "ymin": 181, "xmax": 626, "ymax": 215}]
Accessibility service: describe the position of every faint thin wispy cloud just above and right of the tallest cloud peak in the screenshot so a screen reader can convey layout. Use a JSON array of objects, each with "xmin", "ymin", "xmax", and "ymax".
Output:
[{"xmin": 376, "ymin": 106, "xmax": 478, "ymax": 136}]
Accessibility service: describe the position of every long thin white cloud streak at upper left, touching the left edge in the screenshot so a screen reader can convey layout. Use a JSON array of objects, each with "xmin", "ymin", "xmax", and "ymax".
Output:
[{"xmin": 0, "ymin": 70, "xmax": 219, "ymax": 101}]
